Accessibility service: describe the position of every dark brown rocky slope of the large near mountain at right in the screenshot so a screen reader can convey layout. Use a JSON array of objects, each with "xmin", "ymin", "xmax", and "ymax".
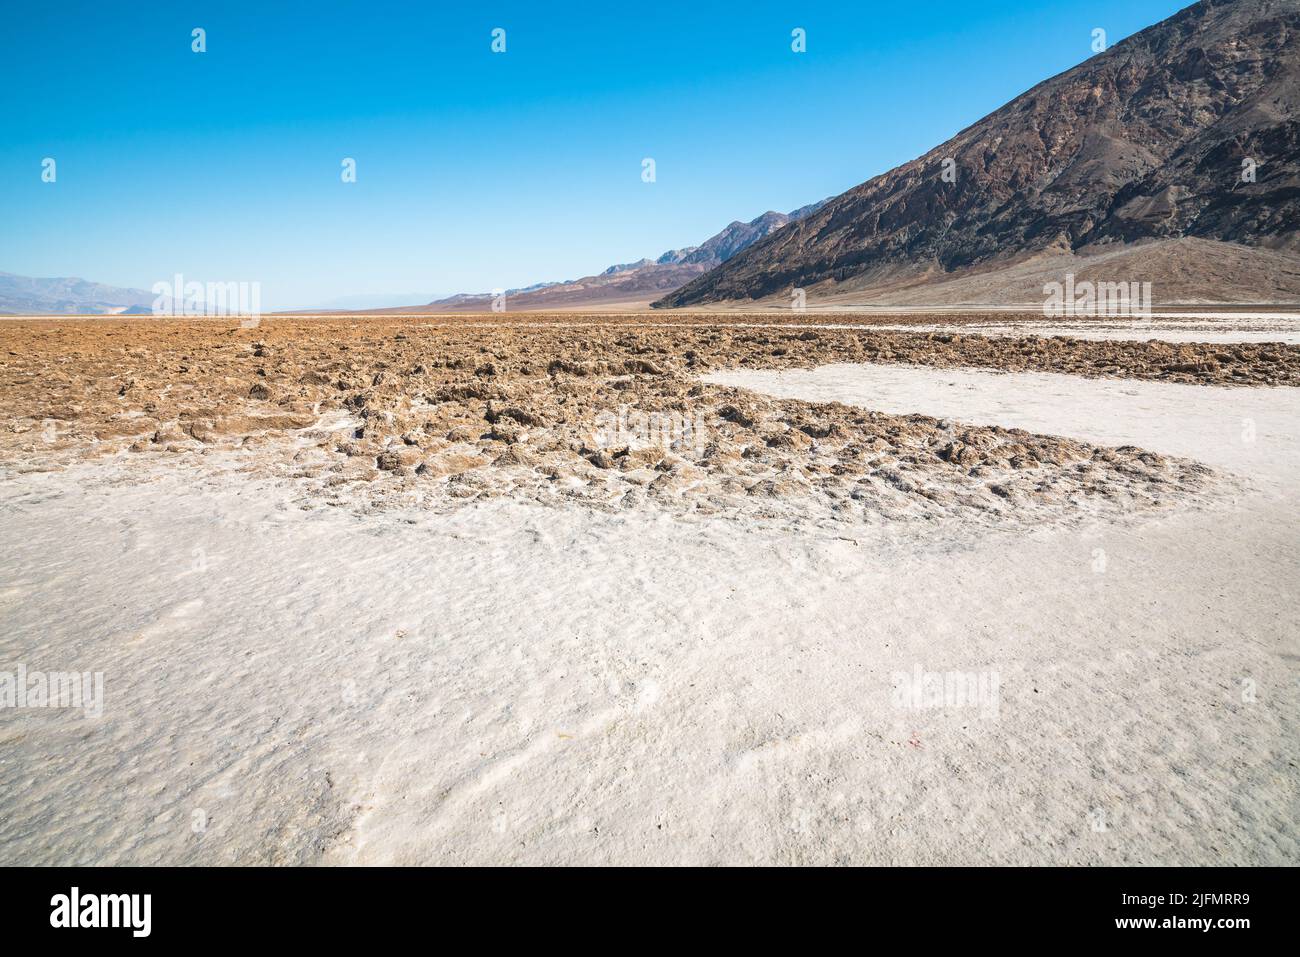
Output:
[{"xmin": 655, "ymin": 0, "xmax": 1300, "ymax": 307}]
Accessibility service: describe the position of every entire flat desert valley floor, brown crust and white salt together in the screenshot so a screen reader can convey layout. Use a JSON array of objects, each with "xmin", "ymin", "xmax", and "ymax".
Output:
[{"xmin": 0, "ymin": 311, "xmax": 1300, "ymax": 865}]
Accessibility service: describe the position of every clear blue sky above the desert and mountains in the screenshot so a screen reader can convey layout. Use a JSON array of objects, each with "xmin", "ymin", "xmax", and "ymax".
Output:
[{"xmin": 0, "ymin": 0, "xmax": 1184, "ymax": 308}]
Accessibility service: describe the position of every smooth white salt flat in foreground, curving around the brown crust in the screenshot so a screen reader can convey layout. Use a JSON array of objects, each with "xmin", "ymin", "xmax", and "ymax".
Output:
[{"xmin": 0, "ymin": 367, "xmax": 1300, "ymax": 865}]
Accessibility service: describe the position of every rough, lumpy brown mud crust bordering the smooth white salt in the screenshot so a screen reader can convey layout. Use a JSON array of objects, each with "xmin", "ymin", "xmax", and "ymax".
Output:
[{"xmin": 0, "ymin": 316, "xmax": 1237, "ymax": 524}]
